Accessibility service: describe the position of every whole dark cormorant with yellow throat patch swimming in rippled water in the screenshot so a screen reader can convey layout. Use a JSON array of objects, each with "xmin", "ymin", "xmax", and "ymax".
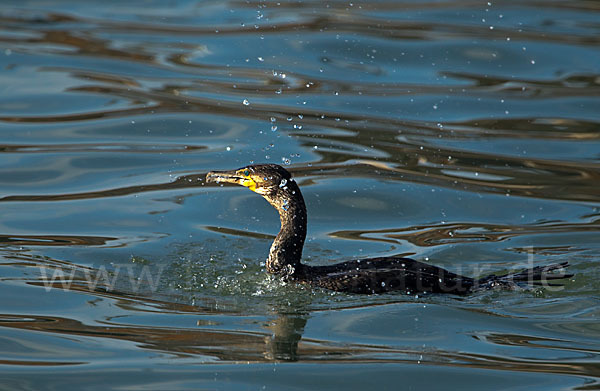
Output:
[{"xmin": 206, "ymin": 164, "xmax": 570, "ymax": 294}]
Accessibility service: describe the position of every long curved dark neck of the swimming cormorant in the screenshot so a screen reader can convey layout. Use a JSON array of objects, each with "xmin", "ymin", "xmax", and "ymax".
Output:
[{"xmin": 265, "ymin": 180, "xmax": 306, "ymax": 276}]
